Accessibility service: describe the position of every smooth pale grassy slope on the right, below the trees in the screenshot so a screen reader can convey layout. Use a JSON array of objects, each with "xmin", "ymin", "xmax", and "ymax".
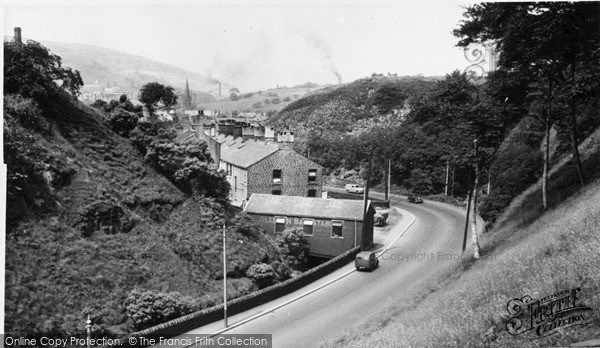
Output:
[{"xmin": 323, "ymin": 130, "xmax": 600, "ymax": 347}]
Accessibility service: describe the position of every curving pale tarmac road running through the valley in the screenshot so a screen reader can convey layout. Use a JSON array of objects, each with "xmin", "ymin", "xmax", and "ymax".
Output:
[{"xmin": 168, "ymin": 193, "xmax": 470, "ymax": 348}]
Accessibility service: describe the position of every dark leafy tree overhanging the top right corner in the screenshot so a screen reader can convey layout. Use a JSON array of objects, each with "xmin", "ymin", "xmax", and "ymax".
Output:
[{"xmin": 454, "ymin": 2, "xmax": 600, "ymax": 186}]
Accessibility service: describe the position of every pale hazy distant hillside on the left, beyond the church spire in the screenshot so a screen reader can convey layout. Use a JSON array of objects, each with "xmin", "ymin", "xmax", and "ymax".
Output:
[{"xmin": 42, "ymin": 41, "xmax": 231, "ymax": 102}]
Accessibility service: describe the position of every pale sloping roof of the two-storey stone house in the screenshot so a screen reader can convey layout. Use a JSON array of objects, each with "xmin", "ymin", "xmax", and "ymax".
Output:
[{"xmin": 221, "ymin": 138, "xmax": 279, "ymax": 168}]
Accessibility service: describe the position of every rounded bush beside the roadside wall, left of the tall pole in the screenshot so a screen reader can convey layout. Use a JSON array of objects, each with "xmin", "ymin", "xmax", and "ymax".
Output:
[{"xmin": 125, "ymin": 288, "xmax": 197, "ymax": 330}]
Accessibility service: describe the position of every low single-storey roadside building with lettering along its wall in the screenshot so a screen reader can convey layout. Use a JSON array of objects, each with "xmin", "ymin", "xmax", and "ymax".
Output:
[{"xmin": 244, "ymin": 194, "xmax": 375, "ymax": 258}]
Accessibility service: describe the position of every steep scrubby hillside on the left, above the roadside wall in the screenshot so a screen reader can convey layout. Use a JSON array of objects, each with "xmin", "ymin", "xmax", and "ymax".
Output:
[{"xmin": 4, "ymin": 86, "xmax": 276, "ymax": 334}]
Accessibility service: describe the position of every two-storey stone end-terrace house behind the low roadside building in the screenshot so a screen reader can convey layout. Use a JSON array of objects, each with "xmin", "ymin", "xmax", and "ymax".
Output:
[{"xmin": 219, "ymin": 132, "xmax": 323, "ymax": 207}]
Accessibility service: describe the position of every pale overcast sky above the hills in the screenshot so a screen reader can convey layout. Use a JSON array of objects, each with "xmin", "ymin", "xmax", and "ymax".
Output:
[{"xmin": 3, "ymin": 0, "xmax": 476, "ymax": 91}]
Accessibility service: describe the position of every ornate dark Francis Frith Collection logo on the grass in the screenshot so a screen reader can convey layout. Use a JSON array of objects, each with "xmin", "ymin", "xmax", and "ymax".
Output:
[{"xmin": 506, "ymin": 288, "xmax": 592, "ymax": 337}]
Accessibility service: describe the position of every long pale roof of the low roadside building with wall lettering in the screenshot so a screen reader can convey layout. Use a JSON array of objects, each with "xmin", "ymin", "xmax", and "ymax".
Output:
[{"xmin": 244, "ymin": 193, "xmax": 371, "ymax": 221}]
